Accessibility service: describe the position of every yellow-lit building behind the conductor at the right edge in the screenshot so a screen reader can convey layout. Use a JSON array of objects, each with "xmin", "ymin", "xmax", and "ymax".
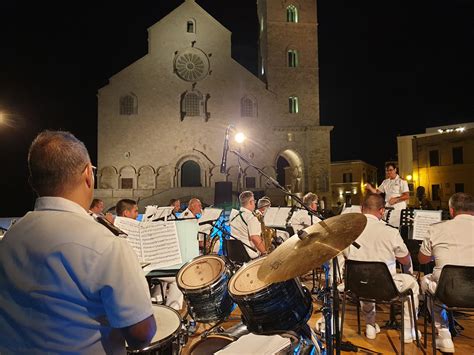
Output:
[{"xmin": 397, "ymin": 123, "xmax": 474, "ymax": 208}]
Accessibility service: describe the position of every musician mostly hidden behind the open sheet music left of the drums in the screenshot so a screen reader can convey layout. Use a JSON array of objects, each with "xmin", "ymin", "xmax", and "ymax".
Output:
[{"xmin": 115, "ymin": 199, "xmax": 183, "ymax": 310}]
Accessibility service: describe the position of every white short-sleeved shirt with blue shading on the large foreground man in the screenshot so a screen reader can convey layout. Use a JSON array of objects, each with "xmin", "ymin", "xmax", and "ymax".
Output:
[{"xmin": 0, "ymin": 197, "xmax": 153, "ymax": 354}]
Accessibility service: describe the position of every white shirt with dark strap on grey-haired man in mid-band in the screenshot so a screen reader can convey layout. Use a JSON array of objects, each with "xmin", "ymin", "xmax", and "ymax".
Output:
[{"xmin": 230, "ymin": 207, "xmax": 262, "ymax": 259}]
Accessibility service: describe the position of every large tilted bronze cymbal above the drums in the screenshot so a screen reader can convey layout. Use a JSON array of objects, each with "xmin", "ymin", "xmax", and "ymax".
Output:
[{"xmin": 257, "ymin": 213, "xmax": 367, "ymax": 283}]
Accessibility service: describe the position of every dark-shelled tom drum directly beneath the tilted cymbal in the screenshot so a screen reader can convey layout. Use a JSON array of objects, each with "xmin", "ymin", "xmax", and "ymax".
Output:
[{"xmin": 229, "ymin": 258, "xmax": 313, "ymax": 334}]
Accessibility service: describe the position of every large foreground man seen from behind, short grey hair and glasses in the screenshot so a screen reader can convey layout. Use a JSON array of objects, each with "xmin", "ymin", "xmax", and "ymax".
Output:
[{"xmin": 0, "ymin": 131, "xmax": 156, "ymax": 354}]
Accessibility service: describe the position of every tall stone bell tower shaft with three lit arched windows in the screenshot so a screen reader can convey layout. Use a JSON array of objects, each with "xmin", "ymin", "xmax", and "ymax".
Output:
[{"xmin": 257, "ymin": 0, "xmax": 320, "ymax": 126}]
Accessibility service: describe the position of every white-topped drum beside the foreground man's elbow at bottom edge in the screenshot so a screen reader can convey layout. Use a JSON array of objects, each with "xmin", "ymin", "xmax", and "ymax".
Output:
[{"xmin": 127, "ymin": 305, "xmax": 182, "ymax": 355}]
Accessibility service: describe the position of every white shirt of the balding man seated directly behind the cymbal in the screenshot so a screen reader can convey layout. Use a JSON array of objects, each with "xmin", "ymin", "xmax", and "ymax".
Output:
[{"xmin": 344, "ymin": 214, "xmax": 408, "ymax": 275}]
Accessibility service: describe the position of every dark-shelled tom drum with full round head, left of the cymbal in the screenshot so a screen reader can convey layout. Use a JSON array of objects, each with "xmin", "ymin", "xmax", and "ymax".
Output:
[{"xmin": 176, "ymin": 255, "xmax": 234, "ymax": 323}]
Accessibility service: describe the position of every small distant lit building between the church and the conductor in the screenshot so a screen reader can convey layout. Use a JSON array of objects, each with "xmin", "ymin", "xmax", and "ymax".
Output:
[{"xmin": 331, "ymin": 160, "xmax": 377, "ymax": 205}]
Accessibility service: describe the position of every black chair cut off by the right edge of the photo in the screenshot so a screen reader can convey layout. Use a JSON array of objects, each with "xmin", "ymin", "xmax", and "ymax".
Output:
[{"xmin": 424, "ymin": 265, "xmax": 474, "ymax": 354}]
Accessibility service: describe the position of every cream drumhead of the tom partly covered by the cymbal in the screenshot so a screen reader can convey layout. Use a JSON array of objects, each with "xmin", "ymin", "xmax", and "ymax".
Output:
[{"xmin": 229, "ymin": 257, "xmax": 271, "ymax": 296}]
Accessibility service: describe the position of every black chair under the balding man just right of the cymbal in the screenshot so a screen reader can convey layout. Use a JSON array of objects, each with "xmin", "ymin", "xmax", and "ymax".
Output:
[{"xmin": 341, "ymin": 260, "xmax": 420, "ymax": 354}]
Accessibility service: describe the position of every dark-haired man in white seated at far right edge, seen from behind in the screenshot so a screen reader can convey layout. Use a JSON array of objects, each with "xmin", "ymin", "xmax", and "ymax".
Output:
[{"xmin": 418, "ymin": 192, "xmax": 474, "ymax": 353}]
